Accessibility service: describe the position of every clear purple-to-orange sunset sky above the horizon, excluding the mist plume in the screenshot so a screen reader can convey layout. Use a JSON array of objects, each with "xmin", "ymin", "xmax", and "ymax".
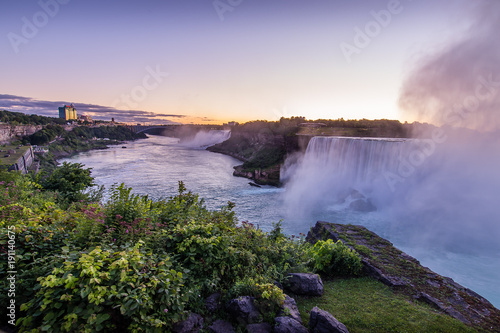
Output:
[{"xmin": 0, "ymin": 0, "xmax": 476, "ymax": 124}]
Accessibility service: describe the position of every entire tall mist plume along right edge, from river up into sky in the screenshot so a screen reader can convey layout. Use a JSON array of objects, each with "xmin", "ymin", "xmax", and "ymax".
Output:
[{"xmin": 393, "ymin": 0, "xmax": 500, "ymax": 252}]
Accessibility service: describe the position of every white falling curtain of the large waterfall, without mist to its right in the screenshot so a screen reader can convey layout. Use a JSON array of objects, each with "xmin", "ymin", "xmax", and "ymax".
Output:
[{"xmin": 283, "ymin": 137, "xmax": 418, "ymax": 214}]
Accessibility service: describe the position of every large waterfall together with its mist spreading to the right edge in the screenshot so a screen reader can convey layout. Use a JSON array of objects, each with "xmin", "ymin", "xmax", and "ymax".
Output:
[{"xmin": 283, "ymin": 130, "xmax": 500, "ymax": 249}]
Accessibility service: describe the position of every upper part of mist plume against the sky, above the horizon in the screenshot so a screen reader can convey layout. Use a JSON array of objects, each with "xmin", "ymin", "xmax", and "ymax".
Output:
[{"xmin": 399, "ymin": 0, "xmax": 500, "ymax": 130}]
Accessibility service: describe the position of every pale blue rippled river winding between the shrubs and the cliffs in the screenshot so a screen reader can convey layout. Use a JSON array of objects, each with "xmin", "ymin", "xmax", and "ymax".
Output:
[{"xmin": 60, "ymin": 136, "xmax": 500, "ymax": 307}]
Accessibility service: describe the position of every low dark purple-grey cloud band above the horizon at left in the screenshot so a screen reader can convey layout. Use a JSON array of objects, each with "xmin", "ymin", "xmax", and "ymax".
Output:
[{"xmin": 0, "ymin": 94, "xmax": 186, "ymax": 124}]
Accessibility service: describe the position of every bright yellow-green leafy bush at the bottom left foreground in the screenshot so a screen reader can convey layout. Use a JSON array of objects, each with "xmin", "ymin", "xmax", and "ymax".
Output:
[{"xmin": 19, "ymin": 242, "xmax": 189, "ymax": 332}]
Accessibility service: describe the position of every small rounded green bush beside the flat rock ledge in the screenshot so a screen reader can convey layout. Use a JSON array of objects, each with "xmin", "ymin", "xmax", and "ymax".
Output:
[{"xmin": 310, "ymin": 239, "xmax": 362, "ymax": 276}]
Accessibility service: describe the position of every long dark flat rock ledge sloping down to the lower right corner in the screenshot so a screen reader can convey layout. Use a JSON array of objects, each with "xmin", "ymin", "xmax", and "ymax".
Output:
[{"xmin": 306, "ymin": 221, "xmax": 500, "ymax": 332}]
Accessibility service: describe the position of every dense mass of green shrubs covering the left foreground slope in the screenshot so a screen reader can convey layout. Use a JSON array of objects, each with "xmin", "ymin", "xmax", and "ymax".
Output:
[{"xmin": 0, "ymin": 162, "xmax": 476, "ymax": 332}]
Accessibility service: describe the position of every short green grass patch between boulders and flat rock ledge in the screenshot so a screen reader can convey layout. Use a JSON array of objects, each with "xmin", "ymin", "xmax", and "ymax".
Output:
[{"xmin": 295, "ymin": 277, "xmax": 477, "ymax": 333}]
